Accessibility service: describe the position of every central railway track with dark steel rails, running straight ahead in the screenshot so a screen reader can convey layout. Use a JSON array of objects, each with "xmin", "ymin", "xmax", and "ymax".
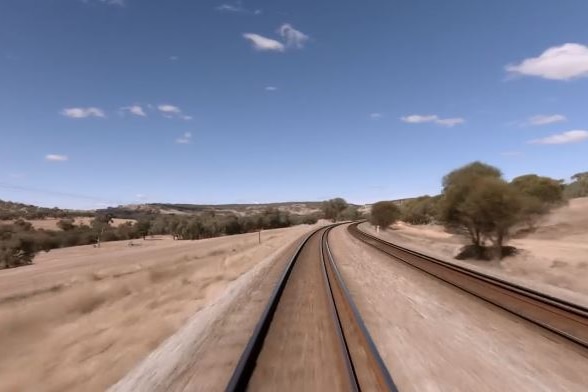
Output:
[{"xmin": 226, "ymin": 226, "xmax": 397, "ymax": 391}]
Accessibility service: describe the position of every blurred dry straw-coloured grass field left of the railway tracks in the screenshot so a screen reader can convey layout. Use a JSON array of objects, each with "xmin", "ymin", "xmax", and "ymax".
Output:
[{"xmin": 0, "ymin": 226, "xmax": 310, "ymax": 391}]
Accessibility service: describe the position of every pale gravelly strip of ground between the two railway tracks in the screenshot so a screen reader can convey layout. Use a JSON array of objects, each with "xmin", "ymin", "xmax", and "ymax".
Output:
[{"xmin": 330, "ymin": 227, "xmax": 588, "ymax": 392}]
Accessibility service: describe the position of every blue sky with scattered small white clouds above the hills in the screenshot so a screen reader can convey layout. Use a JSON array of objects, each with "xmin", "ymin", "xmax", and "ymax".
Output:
[{"xmin": 0, "ymin": 0, "xmax": 588, "ymax": 208}]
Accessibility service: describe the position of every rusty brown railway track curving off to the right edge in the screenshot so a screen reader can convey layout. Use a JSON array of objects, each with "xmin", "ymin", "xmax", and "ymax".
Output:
[{"xmin": 348, "ymin": 223, "xmax": 588, "ymax": 349}]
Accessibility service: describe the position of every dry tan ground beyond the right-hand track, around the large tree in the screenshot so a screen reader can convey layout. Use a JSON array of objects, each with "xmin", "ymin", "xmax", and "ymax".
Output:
[{"xmin": 361, "ymin": 198, "xmax": 588, "ymax": 306}]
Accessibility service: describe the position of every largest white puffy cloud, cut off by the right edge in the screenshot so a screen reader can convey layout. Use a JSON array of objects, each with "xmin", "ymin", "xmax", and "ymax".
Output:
[{"xmin": 505, "ymin": 43, "xmax": 588, "ymax": 80}]
